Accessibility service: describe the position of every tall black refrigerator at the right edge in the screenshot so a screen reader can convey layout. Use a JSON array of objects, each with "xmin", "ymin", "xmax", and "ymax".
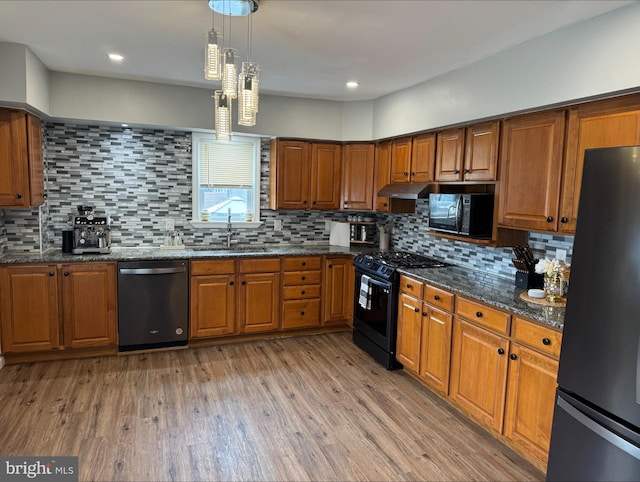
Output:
[{"xmin": 547, "ymin": 146, "xmax": 640, "ymax": 481}]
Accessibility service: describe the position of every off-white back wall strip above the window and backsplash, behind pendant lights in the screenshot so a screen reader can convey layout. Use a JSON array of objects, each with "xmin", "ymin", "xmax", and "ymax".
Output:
[{"xmin": 49, "ymin": 72, "xmax": 342, "ymax": 139}]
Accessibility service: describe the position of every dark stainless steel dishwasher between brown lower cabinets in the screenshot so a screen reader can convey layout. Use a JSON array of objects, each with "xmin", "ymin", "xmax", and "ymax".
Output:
[{"xmin": 118, "ymin": 260, "xmax": 189, "ymax": 351}]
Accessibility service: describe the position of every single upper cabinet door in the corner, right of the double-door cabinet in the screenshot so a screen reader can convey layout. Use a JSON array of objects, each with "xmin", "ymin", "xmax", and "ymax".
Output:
[{"xmin": 342, "ymin": 144, "xmax": 374, "ymax": 211}]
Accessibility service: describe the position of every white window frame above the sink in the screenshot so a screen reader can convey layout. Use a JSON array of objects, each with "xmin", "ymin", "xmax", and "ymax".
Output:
[{"xmin": 190, "ymin": 131, "xmax": 262, "ymax": 229}]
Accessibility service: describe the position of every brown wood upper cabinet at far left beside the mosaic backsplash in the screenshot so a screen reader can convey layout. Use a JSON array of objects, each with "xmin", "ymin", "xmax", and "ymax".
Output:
[{"xmin": 0, "ymin": 109, "xmax": 44, "ymax": 208}]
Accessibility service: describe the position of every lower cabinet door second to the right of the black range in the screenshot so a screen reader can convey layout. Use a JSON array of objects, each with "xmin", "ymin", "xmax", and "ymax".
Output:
[{"xmin": 420, "ymin": 304, "xmax": 453, "ymax": 395}]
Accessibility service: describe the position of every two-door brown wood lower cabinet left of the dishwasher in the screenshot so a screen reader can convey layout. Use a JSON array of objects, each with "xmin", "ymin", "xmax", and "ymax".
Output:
[{"xmin": 0, "ymin": 263, "xmax": 117, "ymax": 354}]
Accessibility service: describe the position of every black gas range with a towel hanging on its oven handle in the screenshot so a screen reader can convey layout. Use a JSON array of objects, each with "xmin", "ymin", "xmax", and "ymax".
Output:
[{"xmin": 353, "ymin": 252, "xmax": 449, "ymax": 370}]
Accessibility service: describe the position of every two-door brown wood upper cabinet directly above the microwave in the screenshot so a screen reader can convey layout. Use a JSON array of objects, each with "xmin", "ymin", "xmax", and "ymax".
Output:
[{"xmin": 435, "ymin": 121, "xmax": 500, "ymax": 182}]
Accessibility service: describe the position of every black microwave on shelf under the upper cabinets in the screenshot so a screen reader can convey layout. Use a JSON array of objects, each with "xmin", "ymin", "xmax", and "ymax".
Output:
[{"xmin": 429, "ymin": 193, "xmax": 493, "ymax": 238}]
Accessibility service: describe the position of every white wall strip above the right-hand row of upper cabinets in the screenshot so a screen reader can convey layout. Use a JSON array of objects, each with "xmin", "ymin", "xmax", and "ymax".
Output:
[{"xmin": 373, "ymin": 4, "xmax": 640, "ymax": 139}]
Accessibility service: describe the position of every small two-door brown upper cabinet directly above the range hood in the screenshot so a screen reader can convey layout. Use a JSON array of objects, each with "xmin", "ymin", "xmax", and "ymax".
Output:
[{"xmin": 391, "ymin": 133, "xmax": 436, "ymax": 183}]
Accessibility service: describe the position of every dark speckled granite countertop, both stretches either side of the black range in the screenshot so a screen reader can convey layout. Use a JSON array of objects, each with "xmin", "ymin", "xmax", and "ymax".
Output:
[{"xmin": 0, "ymin": 244, "xmax": 564, "ymax": 328}]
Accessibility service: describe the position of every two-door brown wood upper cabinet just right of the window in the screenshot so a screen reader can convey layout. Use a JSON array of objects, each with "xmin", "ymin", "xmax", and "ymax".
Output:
[{"xmin": 270, "ymin": 139, "xmax": 342, "ymax": 210}]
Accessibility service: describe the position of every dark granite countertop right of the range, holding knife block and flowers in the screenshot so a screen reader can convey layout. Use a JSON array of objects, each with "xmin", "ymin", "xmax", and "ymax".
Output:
[{"xmin": 400, "ymin": 266, "xmax": 565, "ymax": 329}]
